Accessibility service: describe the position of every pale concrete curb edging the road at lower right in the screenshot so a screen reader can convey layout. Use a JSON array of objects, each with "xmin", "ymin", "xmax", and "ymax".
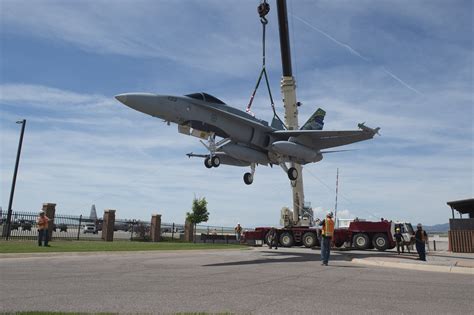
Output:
[{"xmin": 352, "ymin": 258, "xmax": 474, "ymax": 276}]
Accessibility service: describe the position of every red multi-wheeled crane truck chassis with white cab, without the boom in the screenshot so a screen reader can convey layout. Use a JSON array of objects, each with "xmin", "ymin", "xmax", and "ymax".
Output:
[{"xmin": 243, "ymin": 220, "xmax": 414, "ymax": 251}]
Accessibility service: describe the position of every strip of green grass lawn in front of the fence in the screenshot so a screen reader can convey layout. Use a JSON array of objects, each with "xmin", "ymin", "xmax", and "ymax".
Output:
[{"xmin": 0, "ymin": 240, "xmax": 247, "ymax": 257}]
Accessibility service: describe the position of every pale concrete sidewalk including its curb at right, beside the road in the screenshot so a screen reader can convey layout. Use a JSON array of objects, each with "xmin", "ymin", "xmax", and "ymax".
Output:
[{"xmin": 352, "ymin": 251, "xmax": 474, "ymax": 275}]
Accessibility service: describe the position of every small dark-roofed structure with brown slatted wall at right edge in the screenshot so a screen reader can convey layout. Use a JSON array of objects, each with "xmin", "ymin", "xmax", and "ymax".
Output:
[{"xmin": 447, "ymin": 198, "xmax": 474, "ymax": 253}]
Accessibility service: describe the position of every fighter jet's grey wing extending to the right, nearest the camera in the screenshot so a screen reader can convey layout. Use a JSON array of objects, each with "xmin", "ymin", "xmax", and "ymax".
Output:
[{"xmin": 272, "ymin": 124, "xmax": 380, "ymax": 150}]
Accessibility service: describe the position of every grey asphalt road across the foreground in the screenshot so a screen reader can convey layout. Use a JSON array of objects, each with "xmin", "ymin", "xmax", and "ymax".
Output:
[{"xmin": 0, "ymin": 248, "xmax": 474, "ymax": 314}]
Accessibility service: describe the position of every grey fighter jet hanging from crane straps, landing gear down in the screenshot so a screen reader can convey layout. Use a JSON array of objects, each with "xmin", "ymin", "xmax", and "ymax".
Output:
[{"xmin": 115, "ymin": 93, "xmax": 380, "ymax": 185}]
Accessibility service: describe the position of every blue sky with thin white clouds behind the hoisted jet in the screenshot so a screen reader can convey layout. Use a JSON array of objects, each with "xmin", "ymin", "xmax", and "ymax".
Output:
[{"xmin": 0, "ymin": 0, "xmax": 474, "ymax": 227}]
